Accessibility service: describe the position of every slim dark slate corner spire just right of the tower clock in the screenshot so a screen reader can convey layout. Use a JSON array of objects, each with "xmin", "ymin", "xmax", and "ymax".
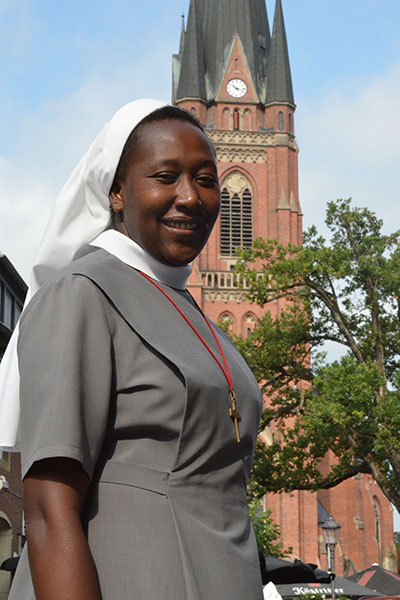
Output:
[{"xmin": 267, "ymin": 0, "xmax": 294, "ymax": 105}]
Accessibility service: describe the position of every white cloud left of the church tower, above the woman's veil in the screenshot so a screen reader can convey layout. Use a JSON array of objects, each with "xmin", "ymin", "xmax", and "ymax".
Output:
[{"xmin": 0, "ymin": 54, "xmax": 170, "ymax": 280}]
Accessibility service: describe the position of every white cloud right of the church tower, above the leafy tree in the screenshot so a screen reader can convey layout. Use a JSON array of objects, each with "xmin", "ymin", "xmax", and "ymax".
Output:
[{"xmin": 297, "ymin": 63, "xmax": 400, "ymax": 237}]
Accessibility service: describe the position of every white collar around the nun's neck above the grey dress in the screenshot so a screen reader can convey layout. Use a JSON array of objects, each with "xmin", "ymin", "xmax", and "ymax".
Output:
[{"xmin": 90, "ymin": 229, "xmax": 192, "ymax": 290}]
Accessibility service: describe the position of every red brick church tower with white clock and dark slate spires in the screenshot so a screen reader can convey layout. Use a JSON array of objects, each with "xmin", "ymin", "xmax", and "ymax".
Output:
[{"xmin": 173, "ymin": 0, "xmax": 302, "ymax": 335}]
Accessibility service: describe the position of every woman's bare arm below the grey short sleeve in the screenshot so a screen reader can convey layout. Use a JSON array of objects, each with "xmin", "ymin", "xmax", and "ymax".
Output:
[{"xmin": 24, "ymin": 458, "xmax": 101, "ymax": 600}]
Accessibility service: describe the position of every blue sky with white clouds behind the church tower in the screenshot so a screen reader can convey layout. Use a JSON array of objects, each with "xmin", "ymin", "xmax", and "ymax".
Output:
[{"xmin": 0, "ymin": 0, "xmax": 400, "ymax": 529}]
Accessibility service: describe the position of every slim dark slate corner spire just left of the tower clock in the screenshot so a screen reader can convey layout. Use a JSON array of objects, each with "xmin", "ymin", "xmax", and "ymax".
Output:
[{"xmin": 176, "ymin": 0, "xmax": 206, "ymax": 100}]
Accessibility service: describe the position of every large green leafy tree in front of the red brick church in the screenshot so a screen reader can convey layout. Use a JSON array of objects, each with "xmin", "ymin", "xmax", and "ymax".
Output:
[{"xmin": 236, "ymin": 200, "xmax": 400, "ymax": 510}]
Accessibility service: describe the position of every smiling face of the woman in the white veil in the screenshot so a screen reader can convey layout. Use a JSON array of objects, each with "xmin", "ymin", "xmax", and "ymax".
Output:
[{"xmin": 110, "ymin": 120, "xmax": 220, "ymax": 266}]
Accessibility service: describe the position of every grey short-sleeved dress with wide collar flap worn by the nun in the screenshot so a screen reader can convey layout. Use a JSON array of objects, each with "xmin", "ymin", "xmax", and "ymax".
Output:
[{"xmin": 10, "ymin": 250, "xmax": 263, "ymax": 600}]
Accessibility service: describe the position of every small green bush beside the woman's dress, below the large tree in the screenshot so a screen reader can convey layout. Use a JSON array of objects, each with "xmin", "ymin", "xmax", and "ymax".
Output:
[{"xmin": 249, "ymin": 500, "xmax": 292, "ymax": 558}]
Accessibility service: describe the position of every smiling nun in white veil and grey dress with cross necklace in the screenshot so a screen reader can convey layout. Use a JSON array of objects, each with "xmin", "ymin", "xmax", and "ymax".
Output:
[{"xmin": 6, "ymin": 101, "xmax": 262, "ymax": 600}]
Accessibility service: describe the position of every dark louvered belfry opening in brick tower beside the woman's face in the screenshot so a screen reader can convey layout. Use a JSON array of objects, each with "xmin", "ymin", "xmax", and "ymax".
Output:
[{"xmin": 220, "ymin": 187, "xmax": 253, "ymax": 256}]
